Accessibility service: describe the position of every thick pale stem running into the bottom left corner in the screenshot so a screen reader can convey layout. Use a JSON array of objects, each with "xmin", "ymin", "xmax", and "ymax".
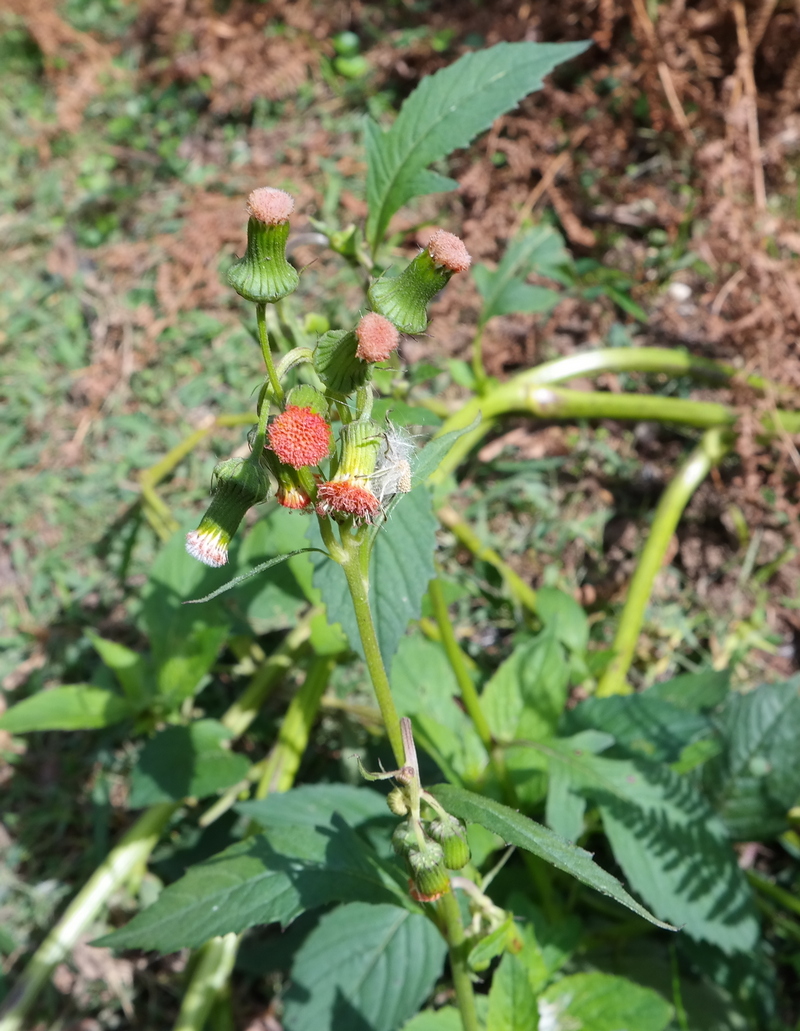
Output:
[{"xmin": 0, "ymin": 802, "xmax": 178, "ymax": 1031}]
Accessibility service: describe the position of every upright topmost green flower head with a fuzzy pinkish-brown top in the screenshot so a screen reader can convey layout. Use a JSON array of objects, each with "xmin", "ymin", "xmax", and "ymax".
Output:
[{"xmin": 227, "ymin": 187, "xmax": 300, "ymax": 304}]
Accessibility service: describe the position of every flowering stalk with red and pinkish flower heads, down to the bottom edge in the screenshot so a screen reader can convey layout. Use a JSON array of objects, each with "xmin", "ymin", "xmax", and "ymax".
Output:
[{"xmin": 187, "ymin": 188, "xmax": 477, "ymax": 1031}]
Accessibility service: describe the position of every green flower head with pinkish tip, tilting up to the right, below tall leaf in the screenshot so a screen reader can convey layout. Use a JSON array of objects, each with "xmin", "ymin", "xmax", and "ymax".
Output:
[{"xmin": 369, "ymin": 229, "xmax": 472, "ymax": 333}]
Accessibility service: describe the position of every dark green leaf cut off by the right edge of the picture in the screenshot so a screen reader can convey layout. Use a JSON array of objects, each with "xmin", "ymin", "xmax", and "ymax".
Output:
[{"xmin": 704, "ymin": 677, "xmax": 800, "ymax": 840}]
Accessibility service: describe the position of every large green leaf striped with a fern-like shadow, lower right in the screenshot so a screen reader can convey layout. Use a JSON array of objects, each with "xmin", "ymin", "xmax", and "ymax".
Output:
[{"xmin": 535, "ymin": 740, "xmax": 759, "ymax": 953}]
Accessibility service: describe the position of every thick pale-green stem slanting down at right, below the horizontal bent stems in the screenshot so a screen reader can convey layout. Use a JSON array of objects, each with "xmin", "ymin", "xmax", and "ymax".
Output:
[{"xmin": 596, "ymin": 428, "xmax": 731, "ymax": 698}]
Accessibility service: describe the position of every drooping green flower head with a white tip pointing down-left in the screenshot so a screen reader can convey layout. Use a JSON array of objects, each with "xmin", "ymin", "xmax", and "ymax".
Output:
[{"xmin": 187, "ymin": 458, "xmax": 269, "ymax": 566}]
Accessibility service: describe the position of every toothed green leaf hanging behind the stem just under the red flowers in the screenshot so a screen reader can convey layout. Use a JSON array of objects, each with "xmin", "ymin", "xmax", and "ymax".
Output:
[{"xmin": 308, "ymin": 487, "xmax": 438, "ymax": 668}]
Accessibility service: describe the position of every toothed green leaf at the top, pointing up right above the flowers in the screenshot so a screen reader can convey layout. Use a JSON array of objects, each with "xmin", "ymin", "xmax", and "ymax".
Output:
[{"xmin": 366, "ymin": 42, "xmax": 589, "ymax": 254}]
